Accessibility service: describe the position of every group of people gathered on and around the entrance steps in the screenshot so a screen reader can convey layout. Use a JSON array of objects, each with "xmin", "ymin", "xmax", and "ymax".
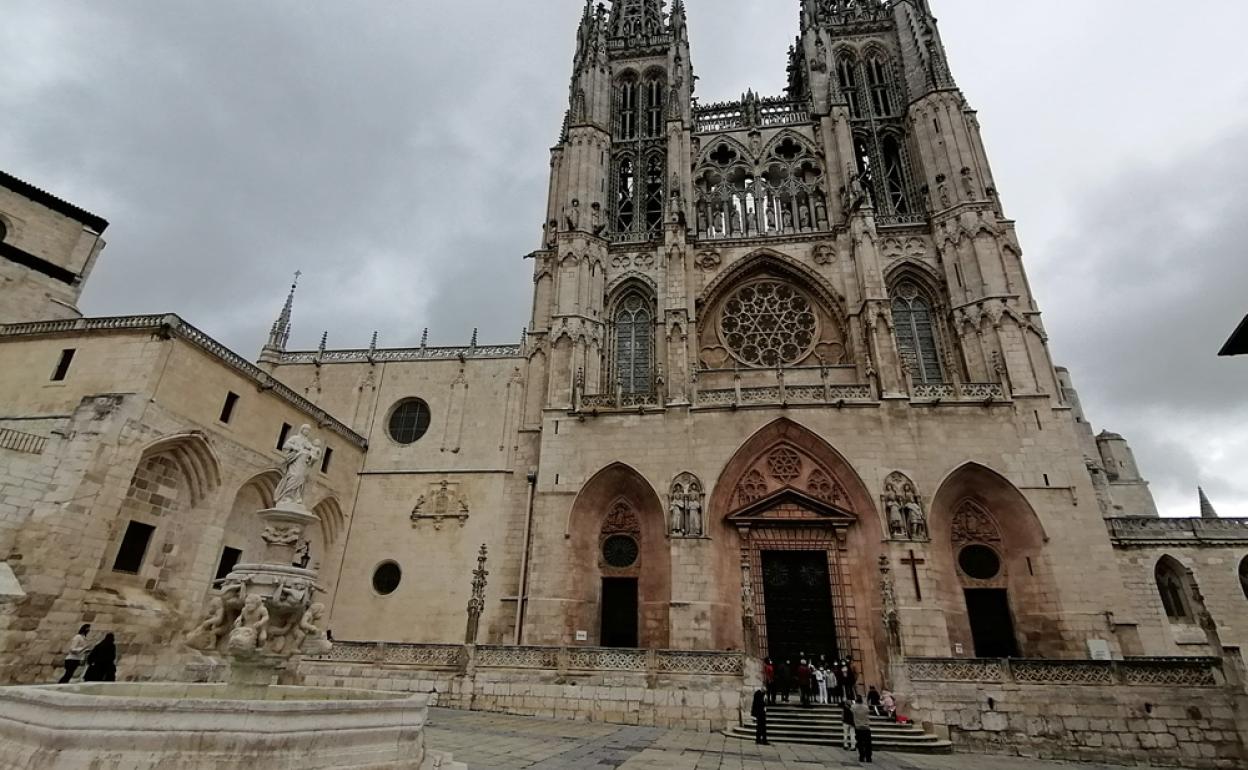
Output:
[{"xmin": 750, "ymin": 654, "xmax": 897, "ymax": 764}]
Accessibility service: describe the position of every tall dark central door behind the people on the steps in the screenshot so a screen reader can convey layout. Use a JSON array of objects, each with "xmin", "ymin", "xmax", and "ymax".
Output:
[{"xmin": 763, "ymin": 550, "xmax": 840, "ymax": 665}]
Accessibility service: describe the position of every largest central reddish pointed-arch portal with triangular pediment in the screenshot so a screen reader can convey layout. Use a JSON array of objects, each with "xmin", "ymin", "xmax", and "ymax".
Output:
[{"xmin": 710, "ymin": 419, "xmax": 886, "ymax": 681}]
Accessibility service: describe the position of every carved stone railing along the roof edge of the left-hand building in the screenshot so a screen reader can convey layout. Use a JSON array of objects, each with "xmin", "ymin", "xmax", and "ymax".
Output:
[{"xmin": 0, "ymin": 313, "xmax": 368, "ymax": 448}]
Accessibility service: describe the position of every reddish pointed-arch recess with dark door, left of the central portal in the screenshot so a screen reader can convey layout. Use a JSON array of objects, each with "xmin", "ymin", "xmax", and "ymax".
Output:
[{"xmin": 563, "ymin": 463, "xmax": 671, "ymax": 649}]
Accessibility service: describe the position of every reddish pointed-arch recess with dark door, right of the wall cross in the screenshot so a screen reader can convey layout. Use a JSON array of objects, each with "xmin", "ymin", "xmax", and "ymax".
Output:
[{"xmin": 929, "ymin": 463, "xmax": 1058, "ymax": 658}]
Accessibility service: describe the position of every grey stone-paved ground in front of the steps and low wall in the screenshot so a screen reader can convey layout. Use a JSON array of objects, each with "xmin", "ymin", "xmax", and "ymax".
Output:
[{"xmin": 427, "ymin": 709, "xmax": 1133, "ymax": 770}]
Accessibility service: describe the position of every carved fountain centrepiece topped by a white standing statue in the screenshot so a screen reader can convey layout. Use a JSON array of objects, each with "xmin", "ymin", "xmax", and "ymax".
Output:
[{"xmin": 186, "ymin": 426, "xmax": 331, "ymax": 685}]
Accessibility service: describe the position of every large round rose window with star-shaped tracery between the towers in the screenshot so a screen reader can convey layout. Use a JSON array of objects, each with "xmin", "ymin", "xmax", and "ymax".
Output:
[{"xmin": 719, "ymin": 281, "xmax": 819, "ymax": 367}]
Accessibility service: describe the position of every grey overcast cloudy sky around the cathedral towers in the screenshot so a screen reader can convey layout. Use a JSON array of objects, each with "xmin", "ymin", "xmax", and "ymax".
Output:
[{"xmin": 0, "ymin": 0, "xmax": 1248, "ymax": 517}]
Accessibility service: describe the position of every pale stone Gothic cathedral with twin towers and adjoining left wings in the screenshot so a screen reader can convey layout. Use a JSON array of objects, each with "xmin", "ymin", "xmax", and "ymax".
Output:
[{"xmin": 0, "ymin": 0, "xmax": 1248, "ymax": 763}]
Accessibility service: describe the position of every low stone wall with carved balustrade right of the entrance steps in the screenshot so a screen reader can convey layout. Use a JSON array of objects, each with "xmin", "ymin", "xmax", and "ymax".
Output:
[{"xmin": 902, "ymin": 658, "xmax": 1248, "ymax": 768}]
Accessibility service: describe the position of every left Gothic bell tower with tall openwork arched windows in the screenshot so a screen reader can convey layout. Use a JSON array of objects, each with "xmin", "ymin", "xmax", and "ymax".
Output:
[{"xmin": 527, "ymin": 0, "xmax": 693, "ymax": 424}]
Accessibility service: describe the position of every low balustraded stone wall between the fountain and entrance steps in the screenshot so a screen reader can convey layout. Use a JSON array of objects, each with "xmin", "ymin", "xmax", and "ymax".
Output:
[{"xmin": 300, "ymin": 643, "xmax": 748, "ymax": 731}]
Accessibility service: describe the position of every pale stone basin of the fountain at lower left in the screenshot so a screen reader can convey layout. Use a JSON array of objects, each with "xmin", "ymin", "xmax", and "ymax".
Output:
[{"xmin": 0, "ymin": 683, "xmax": 464, "ymax": 770}]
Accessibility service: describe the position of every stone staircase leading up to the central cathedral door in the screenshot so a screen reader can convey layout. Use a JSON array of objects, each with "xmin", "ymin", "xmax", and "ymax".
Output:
[{"xmin": 724, "ymin": 703, "xmax": 953, "ymax": 754}]
